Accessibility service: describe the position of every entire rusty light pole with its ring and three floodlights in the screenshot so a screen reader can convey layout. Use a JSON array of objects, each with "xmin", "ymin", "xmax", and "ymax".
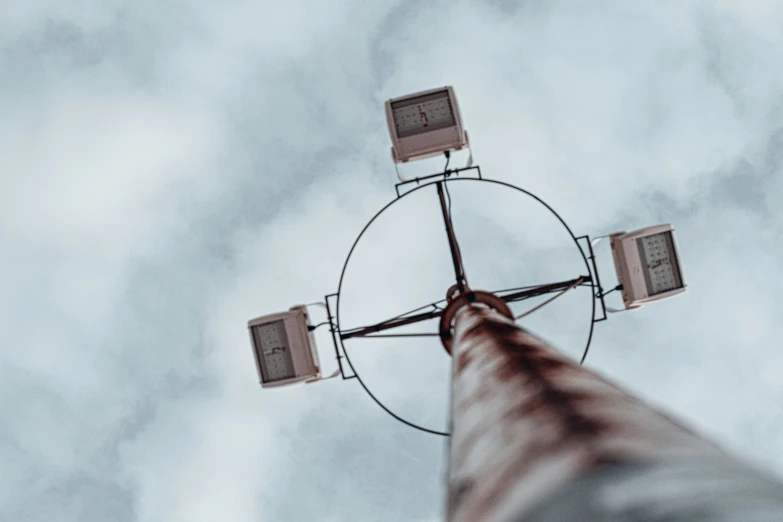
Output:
[{"xmin": 242, "ymin": 87, "xmax": 783, "ymax": 522}]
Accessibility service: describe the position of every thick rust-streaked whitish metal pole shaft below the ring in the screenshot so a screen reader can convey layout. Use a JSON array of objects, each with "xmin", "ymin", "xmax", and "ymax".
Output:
[{"xmin": 447, "ymin": 306, "xmax": 783, "ymax": 522}]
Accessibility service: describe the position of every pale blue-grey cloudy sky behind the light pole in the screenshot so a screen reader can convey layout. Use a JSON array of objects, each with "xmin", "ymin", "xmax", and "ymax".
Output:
[{"xmin": 0, "ymin": 0, "xmax": 783, "ymax": 522}]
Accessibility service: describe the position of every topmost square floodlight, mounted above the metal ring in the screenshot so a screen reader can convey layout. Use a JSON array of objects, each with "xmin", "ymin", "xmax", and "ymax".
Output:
[{"xmin": 386, "ymin": 86, "xmax": 468, "ymax": 163}]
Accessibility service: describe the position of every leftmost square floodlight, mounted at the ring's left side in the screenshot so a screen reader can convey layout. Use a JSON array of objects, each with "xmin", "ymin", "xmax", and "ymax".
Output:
[{"xmin": 247, "ymin": 306, "xmax": 321, "ymax": 388}]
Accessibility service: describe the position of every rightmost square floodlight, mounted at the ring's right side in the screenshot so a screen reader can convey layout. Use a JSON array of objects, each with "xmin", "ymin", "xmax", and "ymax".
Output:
[{"xmin": 609, "ymin": 224, "xmax": 686, "ymax": 309}]
